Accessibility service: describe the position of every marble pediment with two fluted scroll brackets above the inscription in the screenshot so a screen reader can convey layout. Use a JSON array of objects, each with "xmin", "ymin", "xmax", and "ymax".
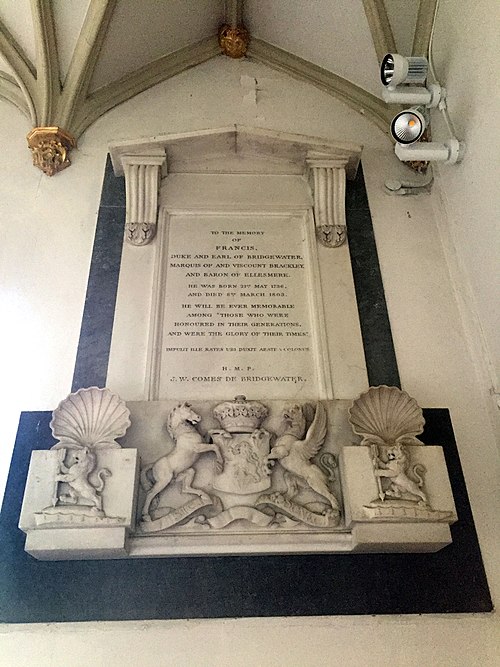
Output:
[{"xmin": 109, "ymin": 125, "xmax": 362, "ymax": 247}]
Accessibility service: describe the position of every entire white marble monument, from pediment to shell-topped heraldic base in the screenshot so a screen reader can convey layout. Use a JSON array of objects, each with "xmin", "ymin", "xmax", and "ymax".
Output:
[{"xmin": 20, "ymin": 126, "xmax": 457, "ymax": 559}]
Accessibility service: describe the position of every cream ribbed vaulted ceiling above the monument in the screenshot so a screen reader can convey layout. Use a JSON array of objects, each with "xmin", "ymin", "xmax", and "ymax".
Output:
[{"xmin": 0, "ymin": 0, "xmax": 436, "ymax": 145}]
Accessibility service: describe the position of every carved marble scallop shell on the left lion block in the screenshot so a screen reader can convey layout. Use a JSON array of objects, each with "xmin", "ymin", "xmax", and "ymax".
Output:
[{"xmin": 50, "ymin": 387, "xmax": 130, "ymax": 449}]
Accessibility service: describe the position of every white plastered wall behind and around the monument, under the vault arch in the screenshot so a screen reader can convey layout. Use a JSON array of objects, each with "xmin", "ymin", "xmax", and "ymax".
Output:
[{"xmin": 0, "ymin": 57, "xmax": 500, "ymax": 667}]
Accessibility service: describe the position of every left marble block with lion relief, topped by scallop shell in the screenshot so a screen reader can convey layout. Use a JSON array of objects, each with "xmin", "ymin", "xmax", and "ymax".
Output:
[{"xmin": 19, "ymin": 387, "xmax": 139, "ymax": 560}]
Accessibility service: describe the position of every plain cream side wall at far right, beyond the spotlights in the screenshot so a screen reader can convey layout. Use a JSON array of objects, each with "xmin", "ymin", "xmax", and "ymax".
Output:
[{"xmin": 433, "ymin": 0, "xmax": 500, "ymax": 420}]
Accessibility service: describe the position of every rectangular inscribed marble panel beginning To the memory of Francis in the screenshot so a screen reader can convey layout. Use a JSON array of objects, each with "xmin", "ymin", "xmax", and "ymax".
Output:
[{"xmin": 154, "ymin": 216, "xmax": 318, "ymax": 398}]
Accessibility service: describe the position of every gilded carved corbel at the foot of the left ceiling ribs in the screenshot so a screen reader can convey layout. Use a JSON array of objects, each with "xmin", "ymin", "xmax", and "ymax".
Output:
[{"xmin": 26, "ymin": 127, "xmax": 76, "ymax": 176}]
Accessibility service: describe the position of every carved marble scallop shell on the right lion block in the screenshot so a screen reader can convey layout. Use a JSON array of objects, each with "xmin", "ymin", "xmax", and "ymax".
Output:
[{"xmin": 349, "ymin": 385, "xmax": 425, "ymax": 445}]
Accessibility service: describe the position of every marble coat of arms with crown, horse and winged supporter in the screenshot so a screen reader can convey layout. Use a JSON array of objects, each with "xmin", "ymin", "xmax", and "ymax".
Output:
[{"xmin": 140, "ymin": 396, "xmax": 340, "ymax": 533}]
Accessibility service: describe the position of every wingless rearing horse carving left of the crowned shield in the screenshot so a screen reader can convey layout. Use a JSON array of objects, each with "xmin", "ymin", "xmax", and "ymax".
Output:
[{"xmin": 141, "ymin": 402, "xmax": 224, "ymax": 521}]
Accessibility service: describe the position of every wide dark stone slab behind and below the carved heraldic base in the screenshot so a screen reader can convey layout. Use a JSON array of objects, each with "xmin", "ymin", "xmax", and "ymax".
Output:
[{"xmin": 0, "ymin": 409, "xmax": 492, "ymax": 624}]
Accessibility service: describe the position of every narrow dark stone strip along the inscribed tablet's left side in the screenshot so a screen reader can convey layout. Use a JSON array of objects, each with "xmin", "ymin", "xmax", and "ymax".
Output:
[{"xmin": 71, "ymin": 156, "xmax": 125, "ymax": 391}]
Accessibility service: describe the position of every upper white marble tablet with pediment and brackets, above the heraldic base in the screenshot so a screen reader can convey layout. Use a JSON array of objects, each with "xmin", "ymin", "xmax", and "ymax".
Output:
[{"xmin": 107, "ymin": 128, "xmax": 367, "ymax": 401}]
